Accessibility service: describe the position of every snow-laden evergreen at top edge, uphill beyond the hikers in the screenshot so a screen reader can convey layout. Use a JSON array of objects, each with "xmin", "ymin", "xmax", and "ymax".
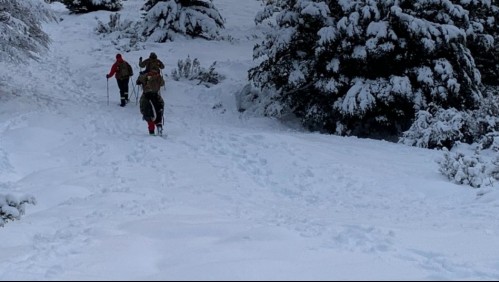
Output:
[{"xmin": 142, "ymin": 0, "xmax": 225, "ymax": 42}]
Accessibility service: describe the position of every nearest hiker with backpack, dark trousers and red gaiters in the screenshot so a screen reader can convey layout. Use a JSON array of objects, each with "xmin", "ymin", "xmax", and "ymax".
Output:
[{"xmin": 137, "ymin": 70, "xmax": 165, "ymax": 135}]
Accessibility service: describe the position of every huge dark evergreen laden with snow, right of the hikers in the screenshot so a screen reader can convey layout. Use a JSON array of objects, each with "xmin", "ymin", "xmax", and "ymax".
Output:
[{"xmin": 249, "ymin": 0, "xmax": 490, "ymax": 138}]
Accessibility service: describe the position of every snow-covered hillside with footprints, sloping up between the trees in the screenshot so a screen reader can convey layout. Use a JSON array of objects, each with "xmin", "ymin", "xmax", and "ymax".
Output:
[{"xmin": 0, "ymin": 0, "xmax": 499, "ymax": 280}]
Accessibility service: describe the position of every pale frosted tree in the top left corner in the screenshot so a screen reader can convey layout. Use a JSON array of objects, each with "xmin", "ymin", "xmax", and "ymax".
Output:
[{"xmin": 0, "ymin": 0, "xmax": 55, "ymax": 62}]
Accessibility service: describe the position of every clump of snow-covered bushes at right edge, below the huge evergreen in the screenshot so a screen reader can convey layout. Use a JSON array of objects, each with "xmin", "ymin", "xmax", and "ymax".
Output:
[{"xmin": 432, "ymin": 87, "xmax": 499, "ymax": 188}]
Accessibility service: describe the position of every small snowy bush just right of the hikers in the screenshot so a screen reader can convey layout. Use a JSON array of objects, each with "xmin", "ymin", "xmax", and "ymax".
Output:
[{"xmin": 171, "ymin": 56, "xmax": 225, "ymax": 87}]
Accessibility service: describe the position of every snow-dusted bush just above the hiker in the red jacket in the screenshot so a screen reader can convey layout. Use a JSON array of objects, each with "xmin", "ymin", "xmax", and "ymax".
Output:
[{"xmin": 95, "ymin": 13, "xmax": 143, "ymax": 52}]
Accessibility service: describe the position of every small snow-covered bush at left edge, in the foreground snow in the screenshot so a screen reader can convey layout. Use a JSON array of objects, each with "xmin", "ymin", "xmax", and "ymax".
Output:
[{"xmin": 0, "ymin": 194, "xmax": 36, "ymax": 227}]
